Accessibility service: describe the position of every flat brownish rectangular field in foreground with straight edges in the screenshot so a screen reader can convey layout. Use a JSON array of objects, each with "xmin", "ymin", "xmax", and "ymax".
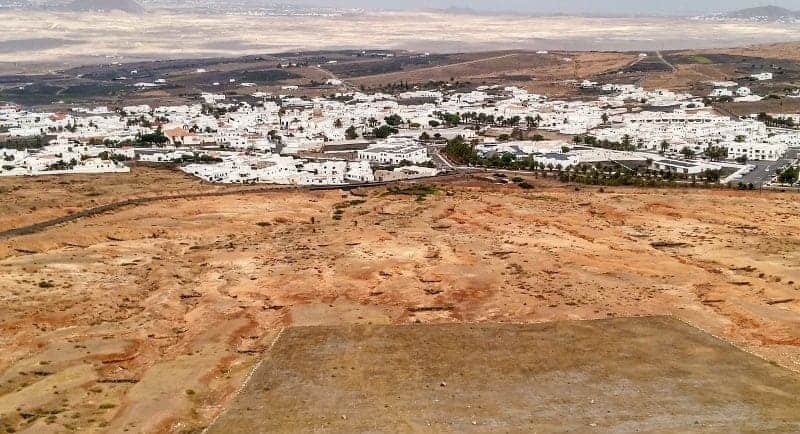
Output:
[{"xmin": 209, "ymin": 317, "xmax": 800, "ymax": 433}]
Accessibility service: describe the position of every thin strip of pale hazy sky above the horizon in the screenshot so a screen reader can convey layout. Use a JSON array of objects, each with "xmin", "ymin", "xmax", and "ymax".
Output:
[{"xmin": 297, "ymin": 0, "xmax": 800, "ymax": 14}]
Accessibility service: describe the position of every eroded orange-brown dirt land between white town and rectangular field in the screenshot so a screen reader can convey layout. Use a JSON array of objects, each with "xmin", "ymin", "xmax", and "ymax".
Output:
[{"xmin": 0, "ymin": 169, "xmax": 800, "ymax": 432}]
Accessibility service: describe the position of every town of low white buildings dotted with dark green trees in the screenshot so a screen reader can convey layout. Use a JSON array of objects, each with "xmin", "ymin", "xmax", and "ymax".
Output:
[{"xmin": 0, "ymin": 77, "xmax": 800, "ymax": 188}]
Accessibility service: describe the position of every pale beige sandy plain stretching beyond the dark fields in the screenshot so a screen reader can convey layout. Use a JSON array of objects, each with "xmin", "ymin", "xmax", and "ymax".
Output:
[{"xmin": 0, "ymin": 11, "xmax": 800, "ymax": 72}]
